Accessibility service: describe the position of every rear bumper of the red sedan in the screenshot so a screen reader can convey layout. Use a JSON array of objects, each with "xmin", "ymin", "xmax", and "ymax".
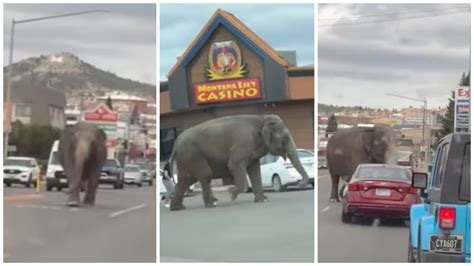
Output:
[{"xmin": 344, "ymin": 203, "xmax": 410, "ymax": 218}]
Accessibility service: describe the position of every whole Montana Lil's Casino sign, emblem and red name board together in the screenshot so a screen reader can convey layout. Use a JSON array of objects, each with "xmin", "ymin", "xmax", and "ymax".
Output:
[{"xmin": 194, "ymin": 41, "xmax": 262, "ymax": 104}]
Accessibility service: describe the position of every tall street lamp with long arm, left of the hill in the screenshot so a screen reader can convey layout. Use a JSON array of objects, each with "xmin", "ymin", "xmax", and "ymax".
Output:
[{"xmin": 3, "ymin": 9, "xmax": 108, "ymax": 159}]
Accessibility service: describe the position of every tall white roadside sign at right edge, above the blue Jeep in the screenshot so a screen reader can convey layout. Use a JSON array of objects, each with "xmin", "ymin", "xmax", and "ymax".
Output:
[{"xmin": 454, "ymin": 86, "xmax": 471, "ymax": 132}]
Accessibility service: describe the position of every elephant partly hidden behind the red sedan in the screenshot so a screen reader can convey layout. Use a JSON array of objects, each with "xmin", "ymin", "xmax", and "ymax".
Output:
[{"xmin": 326, "ymin": 125, "xmax": 396, "ymax": 202}]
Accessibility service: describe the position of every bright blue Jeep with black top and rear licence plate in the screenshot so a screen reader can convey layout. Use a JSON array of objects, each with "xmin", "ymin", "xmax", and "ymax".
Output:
[{"xmin": 408, "ymin": 133, "xmax": 471, "ymax": 262}]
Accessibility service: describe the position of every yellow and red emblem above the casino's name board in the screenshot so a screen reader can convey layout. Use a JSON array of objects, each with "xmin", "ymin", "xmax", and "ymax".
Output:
[{"xmin": 207, "ymin": 41, "xmax": 246, "ymax": 81}]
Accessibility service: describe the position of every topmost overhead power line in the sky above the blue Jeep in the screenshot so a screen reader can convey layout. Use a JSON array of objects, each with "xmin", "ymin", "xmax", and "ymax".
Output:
[{"xmin": 318, "ymin": 9, "xmax": 470, "ymax": 27}]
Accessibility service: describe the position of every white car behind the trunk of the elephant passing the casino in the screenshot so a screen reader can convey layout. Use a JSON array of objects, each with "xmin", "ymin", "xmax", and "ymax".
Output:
[{"xmin": 260, "ymin": 149, "xmax": 314, "ymax": 192}]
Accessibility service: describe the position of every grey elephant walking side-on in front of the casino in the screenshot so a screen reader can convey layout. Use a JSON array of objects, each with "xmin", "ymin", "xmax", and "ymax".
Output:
[{"xmin": 168, "ymin": 115, "xmax": 309, "ymax": 210}]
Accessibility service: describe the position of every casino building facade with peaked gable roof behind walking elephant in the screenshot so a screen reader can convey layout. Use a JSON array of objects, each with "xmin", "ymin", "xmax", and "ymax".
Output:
[{"xmin": 160, "ymin": 9, "xmax": 315, "ymax": 160}]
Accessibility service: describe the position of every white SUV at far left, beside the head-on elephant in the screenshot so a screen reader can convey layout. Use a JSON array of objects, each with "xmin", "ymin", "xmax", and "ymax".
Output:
[{"xmin": 3, "ymin": 157, "xmax": 41, "ymax": 187}]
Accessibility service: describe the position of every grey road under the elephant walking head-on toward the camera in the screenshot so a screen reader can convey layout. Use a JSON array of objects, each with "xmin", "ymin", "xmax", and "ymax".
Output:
[{"xmin": 4, "ymin": 182, "xmax": 156, "ymax": 262}]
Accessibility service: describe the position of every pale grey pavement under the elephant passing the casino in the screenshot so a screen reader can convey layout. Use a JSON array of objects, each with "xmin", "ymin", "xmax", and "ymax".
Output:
[{"xmin": 160, "ymin": 186, "xmax": 314, "ymax": 262}]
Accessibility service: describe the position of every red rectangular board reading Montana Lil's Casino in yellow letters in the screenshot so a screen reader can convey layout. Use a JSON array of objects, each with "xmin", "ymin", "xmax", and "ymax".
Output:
[{"xmin": 194, "ymin": 78, "xmax": 262, "ymax": 104}]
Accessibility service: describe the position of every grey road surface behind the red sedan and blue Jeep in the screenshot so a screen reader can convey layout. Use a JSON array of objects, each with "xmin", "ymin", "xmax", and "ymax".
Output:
[{"xmin": 318, "ymin": 170, "xmax": 408, "ymax": 262}]
